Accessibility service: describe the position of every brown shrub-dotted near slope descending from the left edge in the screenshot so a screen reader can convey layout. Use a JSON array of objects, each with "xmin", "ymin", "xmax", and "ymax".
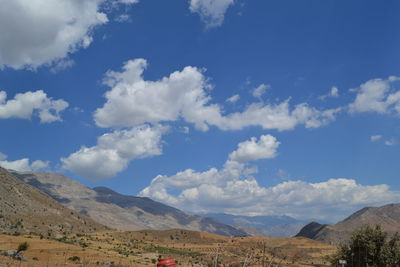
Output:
[{"xmin": 0, "ymin": 168, "xmax": 107, "ymax": 237}]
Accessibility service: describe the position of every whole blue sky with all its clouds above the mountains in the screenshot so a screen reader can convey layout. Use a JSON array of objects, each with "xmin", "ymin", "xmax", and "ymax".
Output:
[{"xmin": 0, "ymin": 0, "xmax": 400, "ymax": 221}]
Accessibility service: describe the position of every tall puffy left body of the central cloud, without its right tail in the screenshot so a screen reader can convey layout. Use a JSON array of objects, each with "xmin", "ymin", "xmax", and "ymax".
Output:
[{"xmin": 94, "ymin": 59, "xmax": 220, "ymax": 128}]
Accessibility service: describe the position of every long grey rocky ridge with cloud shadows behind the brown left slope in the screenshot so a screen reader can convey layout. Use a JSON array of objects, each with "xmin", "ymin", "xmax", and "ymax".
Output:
[{"xmin": 13, "ymin": 172, "xmax": 247, "ymax": 236}]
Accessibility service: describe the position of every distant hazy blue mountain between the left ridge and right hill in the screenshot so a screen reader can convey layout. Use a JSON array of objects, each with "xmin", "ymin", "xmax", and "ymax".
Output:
[{"xmin": 206, "ymin": 213, "xmax": 306, "ymax": 237}]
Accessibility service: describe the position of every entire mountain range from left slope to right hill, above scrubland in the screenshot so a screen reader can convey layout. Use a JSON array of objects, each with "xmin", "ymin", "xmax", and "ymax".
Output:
[{"xmin": 5, "ymin": 168, "xmax": 400, "ymax": 244}]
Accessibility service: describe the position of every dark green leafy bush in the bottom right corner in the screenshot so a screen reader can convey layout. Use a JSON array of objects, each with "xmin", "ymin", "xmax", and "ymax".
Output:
[{"xmin": 331, "ymin": 225, "xmax": 400, "ymax": 267}]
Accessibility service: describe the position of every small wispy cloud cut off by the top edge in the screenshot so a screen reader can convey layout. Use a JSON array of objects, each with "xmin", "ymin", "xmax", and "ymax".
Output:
[{"xmin": 189, "ymin": 0, "xmax": 234, "ymax": 28}]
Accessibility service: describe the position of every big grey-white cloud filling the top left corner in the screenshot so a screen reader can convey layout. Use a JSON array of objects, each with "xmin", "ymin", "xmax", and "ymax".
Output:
[{"xmin": 0, "ymin": 0, "xmax": 138, "ymax": 69}]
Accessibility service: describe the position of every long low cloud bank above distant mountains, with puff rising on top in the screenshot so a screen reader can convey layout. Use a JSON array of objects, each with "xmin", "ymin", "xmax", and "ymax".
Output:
[{"xmin": 140, "ymin": 135, "xmax": 400, "ymax": 220}]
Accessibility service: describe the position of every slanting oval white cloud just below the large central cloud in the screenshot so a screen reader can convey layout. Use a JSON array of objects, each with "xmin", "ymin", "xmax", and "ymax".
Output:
[{"xmin": 61, "ymin": 126, "xmax": 167, "ymax": 179}]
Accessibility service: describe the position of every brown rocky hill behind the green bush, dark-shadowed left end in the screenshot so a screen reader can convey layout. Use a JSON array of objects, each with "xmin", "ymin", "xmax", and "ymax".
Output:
[{"xmin": 296, "ymin": 204, "xmax": 400, "ymax": 244}]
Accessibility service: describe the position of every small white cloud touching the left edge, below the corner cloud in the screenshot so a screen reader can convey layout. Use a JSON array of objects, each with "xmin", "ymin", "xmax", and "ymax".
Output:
[{"xmin": 0, "ymin": 90, "xmax": 68, "ymax": 123}]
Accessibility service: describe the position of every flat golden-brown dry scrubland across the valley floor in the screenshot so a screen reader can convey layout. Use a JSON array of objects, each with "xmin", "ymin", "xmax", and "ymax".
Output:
[{"xmin": 0, "ymin": 230, "xmax": 335, "ymax": 267}]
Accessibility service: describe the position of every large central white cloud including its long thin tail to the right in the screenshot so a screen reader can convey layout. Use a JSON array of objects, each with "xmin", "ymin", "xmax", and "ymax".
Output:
[{"xmin": 94, "ymin": 59, "xmax": 340, "ymax": 131}]
